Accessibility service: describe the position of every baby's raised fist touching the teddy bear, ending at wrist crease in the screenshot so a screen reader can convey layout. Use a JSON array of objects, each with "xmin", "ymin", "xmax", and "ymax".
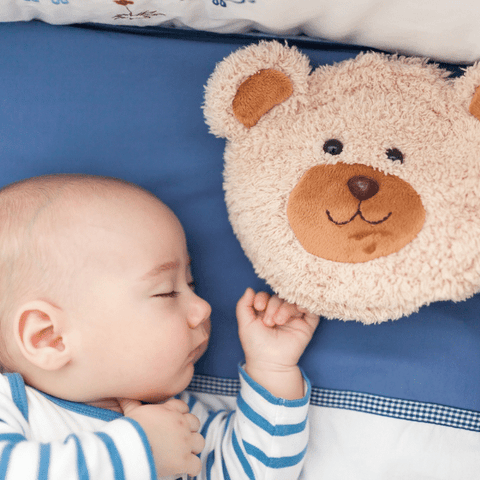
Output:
[{"xmin": 237, "ymin": 288, "xmax": 319, "ymax": 394}]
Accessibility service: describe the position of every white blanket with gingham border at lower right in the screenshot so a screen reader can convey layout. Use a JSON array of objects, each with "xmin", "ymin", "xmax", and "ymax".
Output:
[{"xmin": 191, "ymin": 382, "xmax": 480, "ymax": 480}]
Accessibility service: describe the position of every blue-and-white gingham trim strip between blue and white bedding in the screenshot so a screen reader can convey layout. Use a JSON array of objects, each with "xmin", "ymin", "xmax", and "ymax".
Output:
[{"xmin": 188, "ymin": 375, "xmax": 480, "ymax": 432}]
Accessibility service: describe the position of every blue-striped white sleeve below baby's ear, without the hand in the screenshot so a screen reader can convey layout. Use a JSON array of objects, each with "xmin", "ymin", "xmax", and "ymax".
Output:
[{"xmin": 0, "ymin": 378, "xmax": 156, "ymax": 480}]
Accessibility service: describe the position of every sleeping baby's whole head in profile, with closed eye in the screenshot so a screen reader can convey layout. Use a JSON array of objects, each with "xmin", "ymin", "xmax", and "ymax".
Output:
[{"xmin": 0, "ymin": 175, "xmax": 210, "ymax": 403}]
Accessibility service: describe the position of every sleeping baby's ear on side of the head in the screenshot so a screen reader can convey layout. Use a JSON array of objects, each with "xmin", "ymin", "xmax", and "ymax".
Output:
[{"xmin": 14, "ymin": 300, "xmax": 71, "ymax": 370}]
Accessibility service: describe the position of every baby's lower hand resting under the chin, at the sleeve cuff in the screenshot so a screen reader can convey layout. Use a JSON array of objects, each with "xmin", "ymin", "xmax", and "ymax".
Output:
[{"xmin": 120, "ymin": 398, "xmax": 205, "ymax": 477}]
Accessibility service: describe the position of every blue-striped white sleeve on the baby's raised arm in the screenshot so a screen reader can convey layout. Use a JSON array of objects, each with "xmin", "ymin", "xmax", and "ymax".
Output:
[{"xmin": 190, "ymin": 368, "xmax": 311, "ymax": 480}]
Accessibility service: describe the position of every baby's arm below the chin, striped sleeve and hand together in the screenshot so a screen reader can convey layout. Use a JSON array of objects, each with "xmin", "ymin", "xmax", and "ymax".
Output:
[{"xmin": 0, "ymin": 382, "xmax": 204, "ymax": 480}]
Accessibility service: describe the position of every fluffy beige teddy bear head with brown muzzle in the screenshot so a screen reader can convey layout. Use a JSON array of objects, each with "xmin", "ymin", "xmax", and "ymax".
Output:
[{"xmin": 204, "ymin": 42, "xmax": 480, "ymax": 323}]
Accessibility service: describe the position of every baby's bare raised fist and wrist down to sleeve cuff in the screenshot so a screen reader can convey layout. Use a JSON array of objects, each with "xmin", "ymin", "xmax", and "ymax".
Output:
[{"xmin": 237, "ymin": 288, "xmax": 319, "ymax": 400}]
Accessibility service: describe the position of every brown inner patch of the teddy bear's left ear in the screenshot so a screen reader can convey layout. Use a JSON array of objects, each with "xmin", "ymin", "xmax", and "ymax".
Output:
[{"xmin": 232, "ymin": 69, "xmax": 293, "ymax": 128}]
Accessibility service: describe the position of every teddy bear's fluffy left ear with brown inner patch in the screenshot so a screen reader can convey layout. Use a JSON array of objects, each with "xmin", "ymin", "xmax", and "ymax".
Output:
[{"xmin": 203, "ymin": 41, "xmax": 311, "ymax": 139}]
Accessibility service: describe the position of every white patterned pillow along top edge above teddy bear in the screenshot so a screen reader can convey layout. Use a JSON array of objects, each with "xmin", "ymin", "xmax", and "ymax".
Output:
[{"xmin": 0, "ymin": 0, "xmax": 480, "ymax": 63}]
